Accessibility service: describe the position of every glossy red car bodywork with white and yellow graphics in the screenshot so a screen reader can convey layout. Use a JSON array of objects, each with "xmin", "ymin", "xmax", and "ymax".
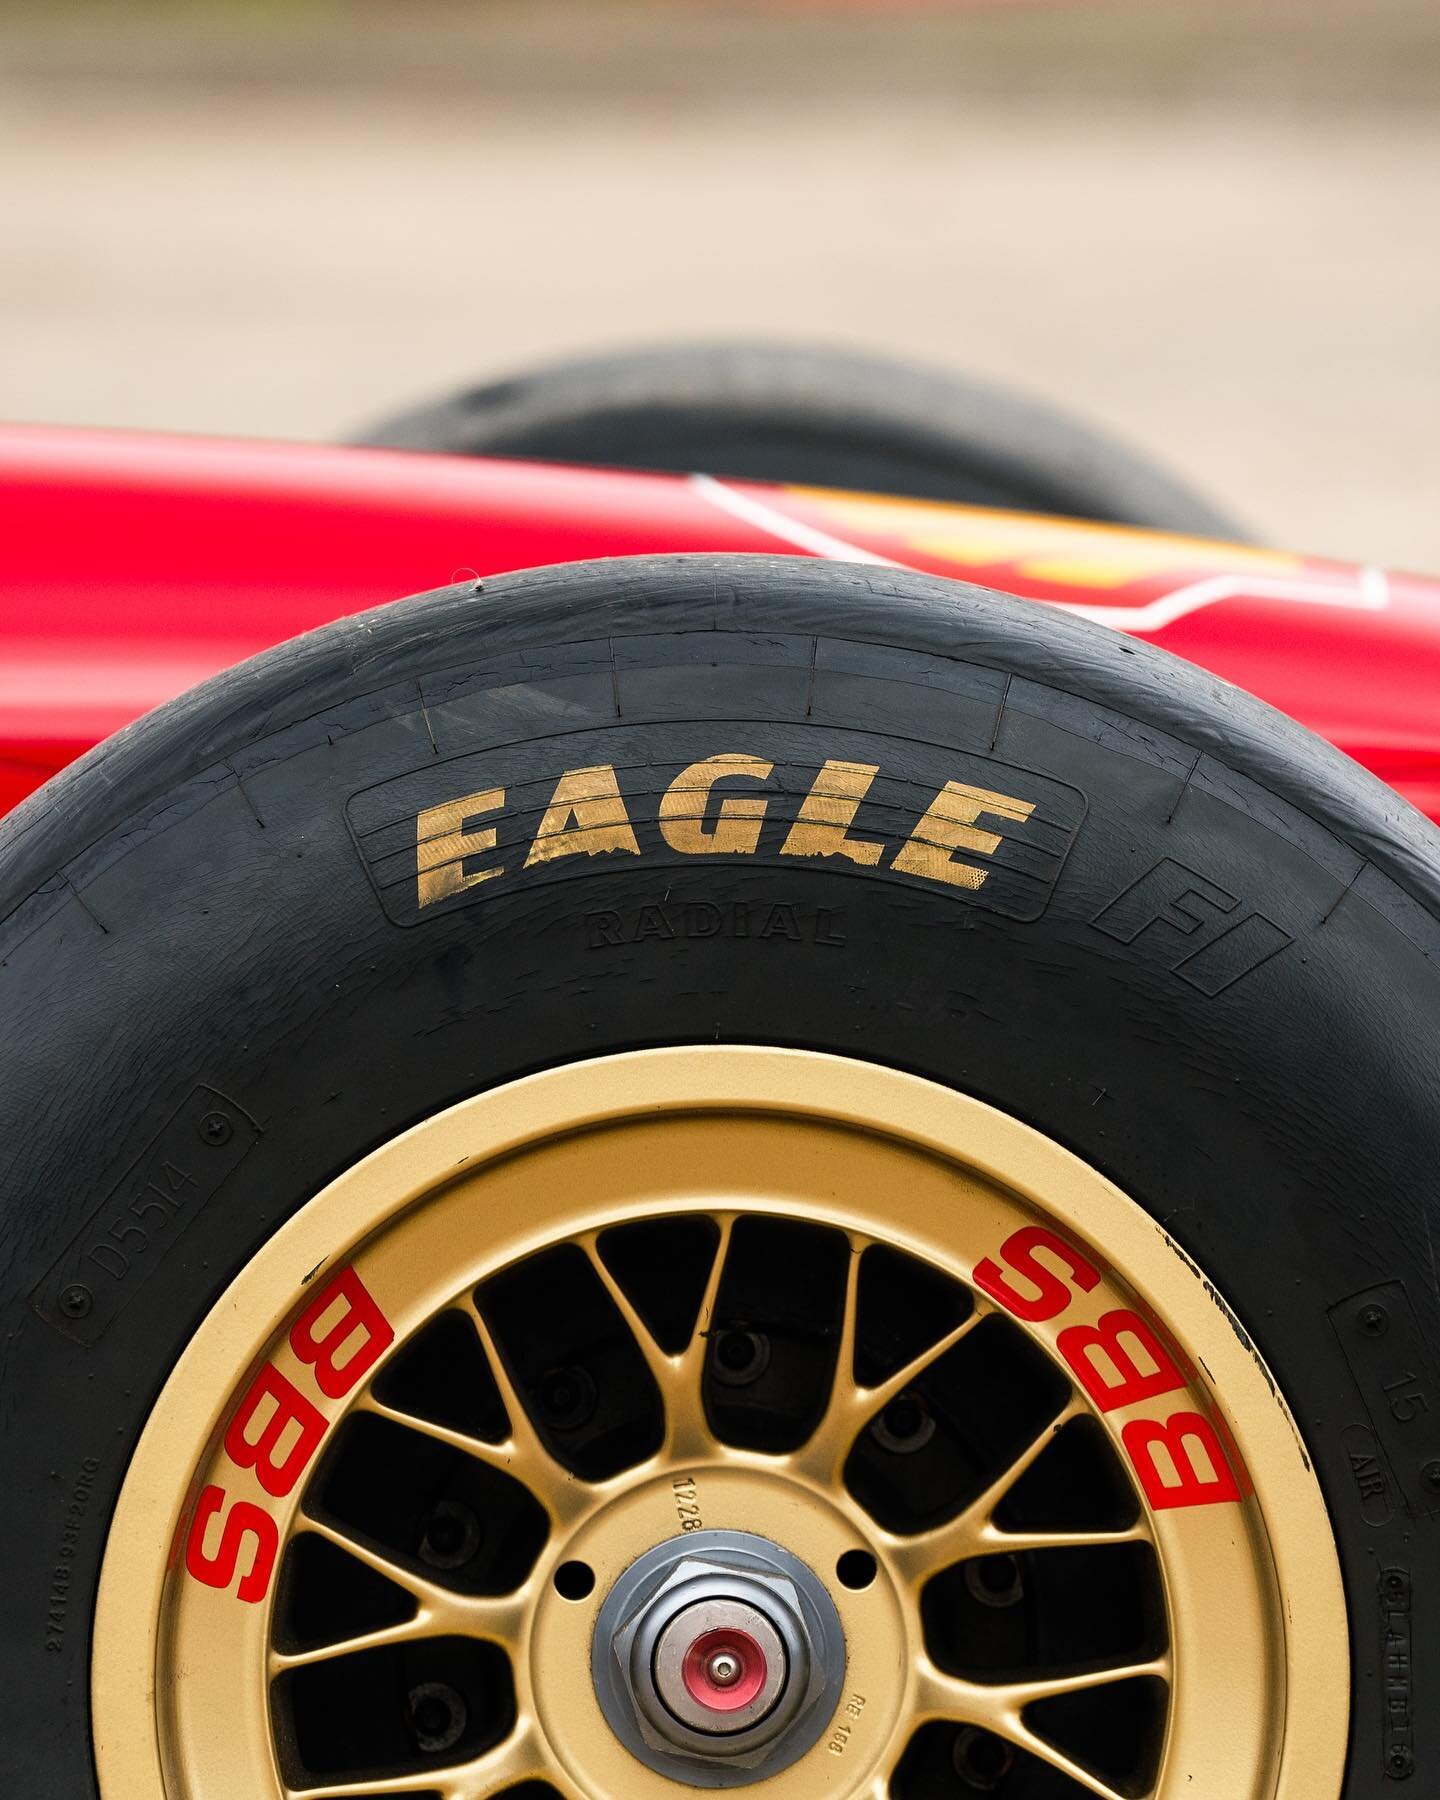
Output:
[{"xmin": 0, "ymin": 427, "xmax": 1440, "ymax": 819}]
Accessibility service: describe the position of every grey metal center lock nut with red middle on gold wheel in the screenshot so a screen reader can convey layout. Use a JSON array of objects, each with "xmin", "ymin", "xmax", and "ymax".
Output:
[{"xmin": 590, "ymin": 1532, "xmax": 844, "ymax": 1787}]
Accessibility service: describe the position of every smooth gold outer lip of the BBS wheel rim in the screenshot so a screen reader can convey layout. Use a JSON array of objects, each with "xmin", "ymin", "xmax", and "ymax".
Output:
[{"xmin": 92, "ymin": 1046, "xmax": 1350, "ymax": 1800}]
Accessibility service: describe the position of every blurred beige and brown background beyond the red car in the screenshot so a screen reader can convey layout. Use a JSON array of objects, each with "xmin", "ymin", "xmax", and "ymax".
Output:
[{"xmin": 0, "ymin": 0, "xmax": 1440, "ymax": 571}]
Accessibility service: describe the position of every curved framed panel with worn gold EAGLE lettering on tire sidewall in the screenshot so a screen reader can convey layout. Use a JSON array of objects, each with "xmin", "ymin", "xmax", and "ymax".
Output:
[{"xmin": 347, "ymin": 724, "xmax": 1085, "ymax": 925}]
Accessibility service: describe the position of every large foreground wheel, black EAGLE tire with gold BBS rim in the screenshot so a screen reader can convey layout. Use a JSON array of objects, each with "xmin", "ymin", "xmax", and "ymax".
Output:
[{"xmin": 0, "ymin": 556, "xmax": 1440, "ymax": 1800}]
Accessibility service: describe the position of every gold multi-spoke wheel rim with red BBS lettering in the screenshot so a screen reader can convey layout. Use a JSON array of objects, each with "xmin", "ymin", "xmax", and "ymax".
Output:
[{"xmin": 92, "ymin": 1048, "xmax": 1348, "ymax": 1800}]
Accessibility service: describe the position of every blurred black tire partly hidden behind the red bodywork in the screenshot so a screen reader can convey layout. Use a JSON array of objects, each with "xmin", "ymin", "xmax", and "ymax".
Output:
[{"xmin": 358, "ymin": 344, "xmax": 1247, "ymax": 542}]
